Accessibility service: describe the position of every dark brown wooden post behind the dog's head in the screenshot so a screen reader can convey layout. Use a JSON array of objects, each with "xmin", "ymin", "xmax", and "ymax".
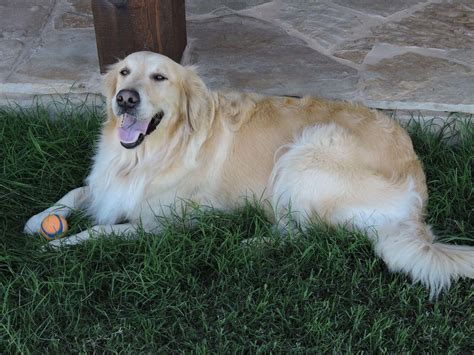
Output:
[{"xmin": 92, "ymin": 0, "xmax": 186, "ymax": 73}]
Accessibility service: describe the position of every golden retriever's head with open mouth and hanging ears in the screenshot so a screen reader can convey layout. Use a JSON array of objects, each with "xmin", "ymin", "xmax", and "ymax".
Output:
[{"xmin": 104, "ymin": 52, "xmax": 210, "ymax": 149}]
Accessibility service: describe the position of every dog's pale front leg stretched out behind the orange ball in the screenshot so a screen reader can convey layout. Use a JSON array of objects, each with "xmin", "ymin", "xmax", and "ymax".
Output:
[{"xmin": 24, "ymin": 186, "xmax": 89, "ymax": 235}]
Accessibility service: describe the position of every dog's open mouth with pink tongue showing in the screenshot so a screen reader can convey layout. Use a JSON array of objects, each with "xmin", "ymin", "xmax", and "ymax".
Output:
[{"xmin": 119, "ymin": 111, "xmax": 163, "ymax": 149}]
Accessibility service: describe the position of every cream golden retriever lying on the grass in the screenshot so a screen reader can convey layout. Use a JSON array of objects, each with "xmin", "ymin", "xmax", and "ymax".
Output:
[{"xmin": 25, "ymin": 52, "xmax": 474, "ymax": 296}]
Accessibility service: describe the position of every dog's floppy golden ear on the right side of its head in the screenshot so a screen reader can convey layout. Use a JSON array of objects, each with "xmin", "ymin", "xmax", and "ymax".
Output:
[{"xmin": 183, "ymin": 67, "xmax": 212, "ymax": 131}]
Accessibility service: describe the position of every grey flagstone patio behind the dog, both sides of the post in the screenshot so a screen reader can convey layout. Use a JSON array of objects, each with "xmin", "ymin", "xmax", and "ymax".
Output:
[{"xmin": 0, "ymin": 0, "xmax": 474, "ymax": 113}]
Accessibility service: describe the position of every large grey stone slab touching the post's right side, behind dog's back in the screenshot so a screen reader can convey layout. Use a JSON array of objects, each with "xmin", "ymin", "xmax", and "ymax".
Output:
[{"xmin": 187, "ymin": 15, "xmax": 359, "ymax": 99}]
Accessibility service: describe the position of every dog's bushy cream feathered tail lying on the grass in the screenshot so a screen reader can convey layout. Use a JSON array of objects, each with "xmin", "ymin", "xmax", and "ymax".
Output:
[{"xmin": 375, "ymin": 221, "xmax": 474, "ymax": 299}]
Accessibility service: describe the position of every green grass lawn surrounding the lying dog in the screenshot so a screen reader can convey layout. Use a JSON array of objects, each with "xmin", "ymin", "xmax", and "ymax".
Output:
[{"xmin": 0, "ymin": 107, "xmax": 474, "ymax": 353}]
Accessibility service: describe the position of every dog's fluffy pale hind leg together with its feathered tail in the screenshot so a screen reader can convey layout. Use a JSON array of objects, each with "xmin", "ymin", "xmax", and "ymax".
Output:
[{"xmin": 272, "ymin": 125, "xmax": 474, "ymax": 299}]
